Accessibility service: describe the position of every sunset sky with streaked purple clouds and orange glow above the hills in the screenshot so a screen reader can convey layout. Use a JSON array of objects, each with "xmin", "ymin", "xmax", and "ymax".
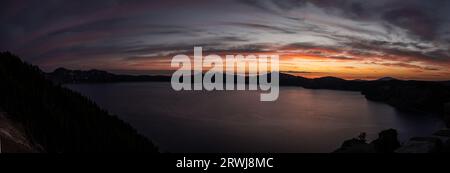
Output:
[{"xmin": 0, "ymin": 0, "xmax": 450, "ymax": 80}]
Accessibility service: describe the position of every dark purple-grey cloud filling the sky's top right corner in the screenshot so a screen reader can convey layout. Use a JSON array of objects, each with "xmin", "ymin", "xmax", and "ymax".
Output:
[{"xmin": 241, "ymin": 0, "xmax": 450, "ymax": 39}]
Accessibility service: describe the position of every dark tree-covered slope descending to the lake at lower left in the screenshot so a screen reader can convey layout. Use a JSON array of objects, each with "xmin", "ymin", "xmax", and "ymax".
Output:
[{"xmin": 0, "ymin": 52, "xmax": 157, "ymax": 153}]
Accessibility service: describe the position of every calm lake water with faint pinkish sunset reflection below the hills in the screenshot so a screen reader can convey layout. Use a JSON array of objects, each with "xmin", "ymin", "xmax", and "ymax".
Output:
[{"xmin": 67, "ymin": 82, "xmax": 443, "ymax": 153}]
